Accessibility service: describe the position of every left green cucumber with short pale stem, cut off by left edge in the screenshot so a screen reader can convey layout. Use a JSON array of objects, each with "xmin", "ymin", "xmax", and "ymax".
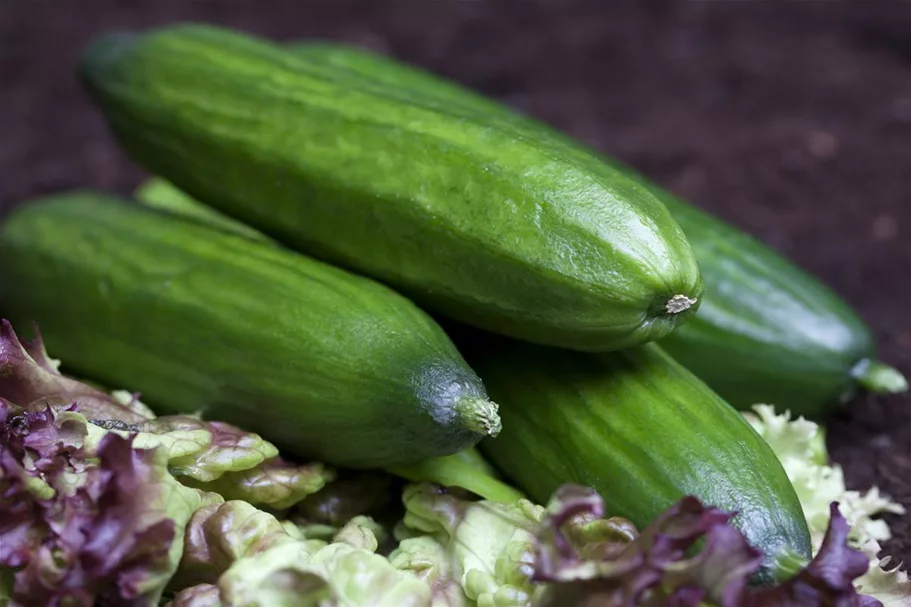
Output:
[{"xmin": 0, "ymin": 192, "xmax": 499, "ymax": 468}]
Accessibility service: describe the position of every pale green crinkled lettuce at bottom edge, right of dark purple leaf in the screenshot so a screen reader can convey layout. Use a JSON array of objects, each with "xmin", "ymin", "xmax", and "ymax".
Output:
[{"xmin": 175, "ymin": 501, "xmax": 430, "ymax": 607}]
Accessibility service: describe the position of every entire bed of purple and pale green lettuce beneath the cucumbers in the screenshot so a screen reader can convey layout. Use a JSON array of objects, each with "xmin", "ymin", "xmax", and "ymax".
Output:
[{"xmin": 0, "ymin": 322, "xmax": 911, "ymax": 607}]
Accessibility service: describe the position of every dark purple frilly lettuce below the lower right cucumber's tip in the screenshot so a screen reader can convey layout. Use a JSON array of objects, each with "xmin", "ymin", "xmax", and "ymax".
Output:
[{"xmin": 534, "ymin": 486, "xmax": 881, "ymax": 607}]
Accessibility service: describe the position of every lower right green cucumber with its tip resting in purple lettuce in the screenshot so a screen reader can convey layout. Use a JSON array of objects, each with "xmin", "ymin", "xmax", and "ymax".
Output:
[{"xmin": 460, "ymin": 337, "xmax": 810, "ymax": 579}]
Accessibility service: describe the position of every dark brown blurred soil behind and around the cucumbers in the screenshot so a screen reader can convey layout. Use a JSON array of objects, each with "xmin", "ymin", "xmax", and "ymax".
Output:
[{"xmin": 0, "ymin": 0, "xmax": 911, "ymax": 562}]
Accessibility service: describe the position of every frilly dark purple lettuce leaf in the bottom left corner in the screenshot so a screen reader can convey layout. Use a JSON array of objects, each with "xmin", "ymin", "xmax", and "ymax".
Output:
[{"xmin": 0, "ymin": 407, "xmax": 218, "ymax": 606}]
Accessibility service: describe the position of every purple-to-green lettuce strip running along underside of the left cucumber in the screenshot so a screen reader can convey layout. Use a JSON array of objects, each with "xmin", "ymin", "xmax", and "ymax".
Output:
[{"xmin": 0, "ymin": 321, "xmax": 334, "ymax": 509}]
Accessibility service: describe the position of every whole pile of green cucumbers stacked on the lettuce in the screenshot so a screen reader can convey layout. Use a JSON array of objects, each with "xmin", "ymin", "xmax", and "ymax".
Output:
[{"xmin": 0, "ymin": 25, "xmax": 907, "ymax": 580}]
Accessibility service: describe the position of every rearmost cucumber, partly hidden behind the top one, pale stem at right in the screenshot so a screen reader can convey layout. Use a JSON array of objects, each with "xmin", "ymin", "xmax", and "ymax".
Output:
[{"xmin": 284, "ymin": 42, "xmax": 908, "ymax": 417}]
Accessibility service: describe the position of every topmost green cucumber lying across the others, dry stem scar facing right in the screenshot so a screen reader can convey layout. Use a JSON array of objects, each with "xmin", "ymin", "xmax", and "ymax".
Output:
[{"xmin": 81, "ymin": 25, "xmax": 702, "ymax": 351}]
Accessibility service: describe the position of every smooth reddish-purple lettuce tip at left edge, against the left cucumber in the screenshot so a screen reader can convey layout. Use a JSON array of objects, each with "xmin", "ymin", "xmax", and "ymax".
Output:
[{"xmin": 0, "ymin": 320, "xmax": 147, "ymax": 423}]
